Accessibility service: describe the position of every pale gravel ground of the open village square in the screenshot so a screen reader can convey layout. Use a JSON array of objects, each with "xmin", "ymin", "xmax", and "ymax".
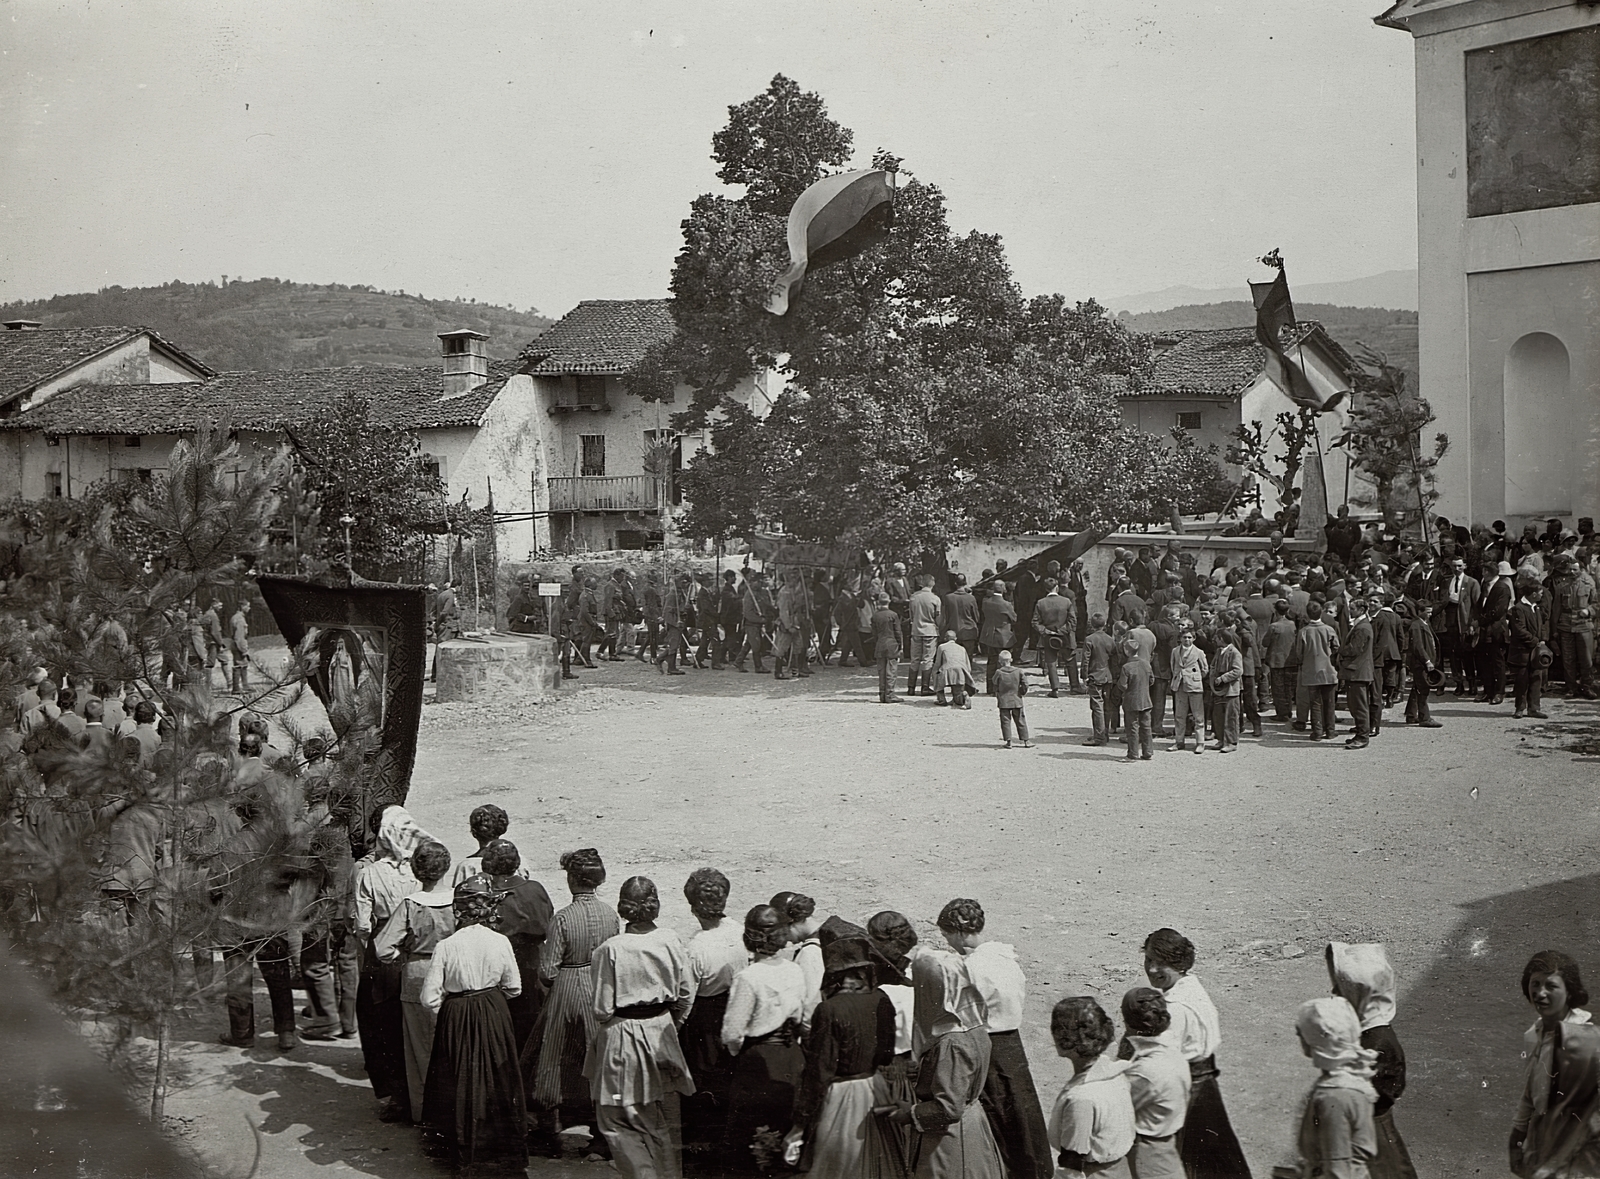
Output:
[{"xmin": 159, "ymin": 661, "xmax": 1600, "ymax": 1179}]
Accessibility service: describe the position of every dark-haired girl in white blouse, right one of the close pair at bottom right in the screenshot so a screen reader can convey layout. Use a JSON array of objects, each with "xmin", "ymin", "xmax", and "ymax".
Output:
[{"xmin": 1118, "ymin": 987, "xmax": 1190, "ymax": 1179}]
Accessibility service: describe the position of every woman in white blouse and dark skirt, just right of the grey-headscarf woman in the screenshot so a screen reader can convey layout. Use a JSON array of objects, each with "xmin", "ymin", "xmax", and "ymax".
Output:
[{"xmin": 939, "ymin": 897, "xmax": 1056, "ymax": 1179}]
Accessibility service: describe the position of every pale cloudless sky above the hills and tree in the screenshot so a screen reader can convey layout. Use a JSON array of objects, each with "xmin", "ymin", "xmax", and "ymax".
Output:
[{"xmin": 0, "ymin": 0, "xmax": 1416, "ymax": 314}]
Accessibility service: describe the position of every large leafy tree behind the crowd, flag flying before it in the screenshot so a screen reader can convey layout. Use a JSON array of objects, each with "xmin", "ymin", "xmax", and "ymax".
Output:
[{"xmin": 627, "ymin": 75, "xmax": 1226, "ymax": 552}]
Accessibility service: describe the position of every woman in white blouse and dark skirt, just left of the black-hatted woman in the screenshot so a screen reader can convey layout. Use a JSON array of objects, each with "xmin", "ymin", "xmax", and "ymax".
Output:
[{"xmin": 722, "ymin": 905, "xmax": 811, "ymax": 1173}]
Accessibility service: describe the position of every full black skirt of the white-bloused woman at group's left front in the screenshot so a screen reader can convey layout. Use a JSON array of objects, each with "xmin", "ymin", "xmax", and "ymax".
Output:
[{"xmin": 422, "ymin": 987, "xmax": 528, "ymax": 1171}]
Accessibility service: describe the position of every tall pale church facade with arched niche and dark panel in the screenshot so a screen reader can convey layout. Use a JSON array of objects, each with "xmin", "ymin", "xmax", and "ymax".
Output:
[{"xmin": 1376, "ymin": 0, "xmax": 1600, "ymax": 531}]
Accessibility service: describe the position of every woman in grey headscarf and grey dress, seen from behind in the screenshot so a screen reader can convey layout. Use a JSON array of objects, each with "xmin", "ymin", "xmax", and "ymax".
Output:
[{"xmin": 888, "ymin": 952, "xmax": 1005, "ymax": 1179}]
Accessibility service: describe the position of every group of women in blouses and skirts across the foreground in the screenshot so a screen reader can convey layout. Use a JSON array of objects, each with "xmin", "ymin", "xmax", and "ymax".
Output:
[{"xmin": 200, "ymin": 806, "xmax": 1600, "ymax": 1179}]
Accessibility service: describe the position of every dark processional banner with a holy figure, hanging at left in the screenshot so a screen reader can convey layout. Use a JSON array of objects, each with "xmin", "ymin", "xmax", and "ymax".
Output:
[{"xmin": 256, "ymin": 574, "xmax": 427, "ymax": 817}]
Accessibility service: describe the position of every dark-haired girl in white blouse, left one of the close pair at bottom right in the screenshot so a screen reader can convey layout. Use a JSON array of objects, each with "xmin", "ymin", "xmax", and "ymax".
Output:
[{"xmin": 1050, "ymin": 997, "xmax": 1134, "ymax": 1179}]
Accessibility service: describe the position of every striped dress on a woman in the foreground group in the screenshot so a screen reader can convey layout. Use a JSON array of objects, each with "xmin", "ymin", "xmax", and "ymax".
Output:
[{"xmin": 523, "ymin": 893, "xmax": 622, "ymax": 1109}]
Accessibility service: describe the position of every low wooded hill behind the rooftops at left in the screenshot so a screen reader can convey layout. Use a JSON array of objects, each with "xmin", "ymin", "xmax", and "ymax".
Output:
[{"xmin": 0, "ymin": 278, "xmax": 550, "ymax": 371}]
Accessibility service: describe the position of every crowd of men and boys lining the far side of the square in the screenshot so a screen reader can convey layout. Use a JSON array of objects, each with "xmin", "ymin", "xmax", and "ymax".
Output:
[{"xmin": 521, "ymin": 507, "xmax": 1600, "ymax": 760}]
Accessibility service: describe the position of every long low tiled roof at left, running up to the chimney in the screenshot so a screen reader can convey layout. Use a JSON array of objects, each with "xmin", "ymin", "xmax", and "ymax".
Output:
[{"xmin": 0, "ymin": 360, "xmax": 515, "ymax": 434}]
